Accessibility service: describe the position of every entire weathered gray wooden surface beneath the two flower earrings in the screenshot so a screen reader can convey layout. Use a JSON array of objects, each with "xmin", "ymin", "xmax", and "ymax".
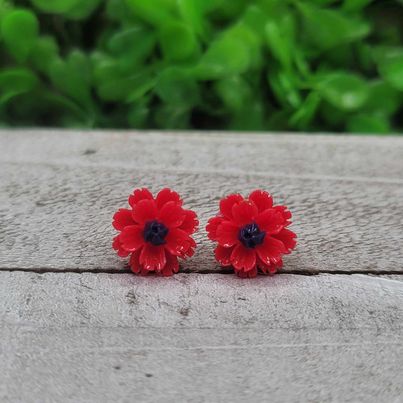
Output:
[{"xmin": 0, "ymin": 131, "xmax": 403, "ymax": 403}]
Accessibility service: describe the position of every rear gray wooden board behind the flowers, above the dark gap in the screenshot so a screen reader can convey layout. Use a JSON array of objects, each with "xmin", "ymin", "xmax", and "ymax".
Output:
[{"xmin": 0, "ymin": 131, "xmax": 403, "ymax": 273}]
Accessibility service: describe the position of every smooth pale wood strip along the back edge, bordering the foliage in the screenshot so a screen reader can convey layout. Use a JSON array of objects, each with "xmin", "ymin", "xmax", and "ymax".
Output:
[{"xmin": 0, "ymin": 130, "xmax": 403, "ymax": 181}]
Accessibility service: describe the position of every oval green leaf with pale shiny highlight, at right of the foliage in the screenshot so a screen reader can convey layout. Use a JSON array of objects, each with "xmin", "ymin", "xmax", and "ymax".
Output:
[{"xmin": 316, "ymin": 72, "xmax": 369, "ymax": 111}]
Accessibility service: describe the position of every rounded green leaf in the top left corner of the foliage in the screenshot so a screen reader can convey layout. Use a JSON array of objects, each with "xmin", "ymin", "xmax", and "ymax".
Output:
[{"xmin": 1, "ymin": 9, "xmax": 39, "ymax": 62}]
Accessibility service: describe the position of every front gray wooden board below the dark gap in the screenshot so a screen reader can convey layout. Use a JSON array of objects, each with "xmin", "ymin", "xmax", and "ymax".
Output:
[{"xmin": 0, "ymin": 272, "xmax": 403, "ymax": 403}]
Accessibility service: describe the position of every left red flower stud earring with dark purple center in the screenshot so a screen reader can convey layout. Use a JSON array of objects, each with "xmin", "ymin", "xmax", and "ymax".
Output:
[{"xmin": 112, "ymin": 189, "xmax": 199, "ymax": 276}]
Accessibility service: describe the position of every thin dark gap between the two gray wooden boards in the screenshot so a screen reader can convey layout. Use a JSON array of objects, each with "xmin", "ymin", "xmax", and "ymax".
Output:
[{"xmin": 0, "ymin": 267, "xmax": 403, "ymax": 276}]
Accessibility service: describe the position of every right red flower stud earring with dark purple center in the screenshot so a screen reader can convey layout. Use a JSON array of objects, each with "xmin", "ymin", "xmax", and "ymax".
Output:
[{"xmin": 206, "ymin": 190, "xmax": 296, "ymax": 277}]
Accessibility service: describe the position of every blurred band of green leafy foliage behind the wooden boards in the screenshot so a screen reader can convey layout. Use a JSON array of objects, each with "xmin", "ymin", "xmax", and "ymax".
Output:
[{"xmin": 0, "ymin": 0, "xmax": 403, "ymax": 133}]
